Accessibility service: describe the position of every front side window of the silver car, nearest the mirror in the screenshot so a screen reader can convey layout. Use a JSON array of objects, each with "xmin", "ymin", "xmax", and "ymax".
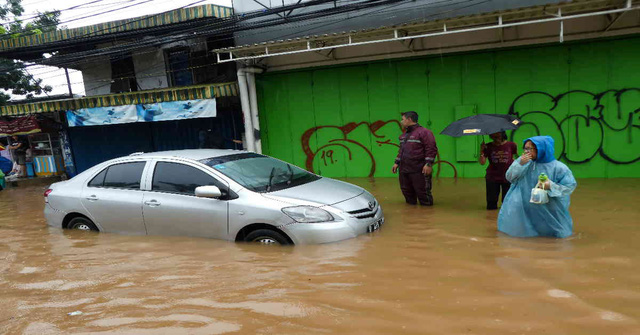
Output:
[{"xmin": 151, "ymin": 162, "xmax": 226, "ymax": 195}]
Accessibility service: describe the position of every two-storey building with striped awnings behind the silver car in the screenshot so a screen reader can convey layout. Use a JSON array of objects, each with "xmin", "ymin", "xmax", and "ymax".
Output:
[{"xmin": 0, "ymin": 5, "xmax": 243, "ymax": 175}]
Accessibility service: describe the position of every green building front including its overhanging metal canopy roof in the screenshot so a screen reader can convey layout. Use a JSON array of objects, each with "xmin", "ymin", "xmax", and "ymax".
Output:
[{"xmin": 217, "ymin": 0, "xmax": 640, "ymax": 178}]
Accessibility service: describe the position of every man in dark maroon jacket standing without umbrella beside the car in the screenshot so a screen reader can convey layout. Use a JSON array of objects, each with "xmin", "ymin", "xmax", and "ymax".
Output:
[{"xmin": 391, "ymin": 112, "xmax": 438, "ymax": 206}]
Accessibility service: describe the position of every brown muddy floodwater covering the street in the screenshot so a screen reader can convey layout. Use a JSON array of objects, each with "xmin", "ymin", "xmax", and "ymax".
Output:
[{"xmin": 0, "ymin": 179, "xmax": 640, "ymax": 334}]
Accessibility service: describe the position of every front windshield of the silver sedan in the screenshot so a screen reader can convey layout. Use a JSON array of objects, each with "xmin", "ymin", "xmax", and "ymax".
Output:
[{"xmin": 200, "ymin": 153, "xmax": 321, "ymax": 193}]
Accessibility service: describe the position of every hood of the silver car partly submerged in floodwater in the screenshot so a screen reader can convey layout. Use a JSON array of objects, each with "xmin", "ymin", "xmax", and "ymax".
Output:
[{"xmin": 262, "ymin": 178, "xmax": 364, "ymax": 206}]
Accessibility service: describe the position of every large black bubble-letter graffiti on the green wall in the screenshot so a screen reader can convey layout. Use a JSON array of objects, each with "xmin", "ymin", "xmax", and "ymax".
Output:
[{"xmin": 509, "ymin": 88, "xmax": 640, "ymax": 164}]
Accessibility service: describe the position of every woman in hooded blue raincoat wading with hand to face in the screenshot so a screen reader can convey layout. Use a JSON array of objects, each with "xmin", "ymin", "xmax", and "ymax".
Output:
[{"xmin": 498, "ymin": 136, "xmax": 577, "ymax": 238}]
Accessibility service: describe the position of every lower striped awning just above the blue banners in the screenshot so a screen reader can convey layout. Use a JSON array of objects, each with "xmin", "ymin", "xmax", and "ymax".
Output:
[{"xmin": 0, "ymin": 82, "xmax": 238, "ymax": 116}]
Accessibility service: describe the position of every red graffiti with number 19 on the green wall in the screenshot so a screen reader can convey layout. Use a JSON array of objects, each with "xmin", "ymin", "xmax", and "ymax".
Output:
[{"xmin": 301, "ymin": 120, "xmax": 458, "ymax": 177}]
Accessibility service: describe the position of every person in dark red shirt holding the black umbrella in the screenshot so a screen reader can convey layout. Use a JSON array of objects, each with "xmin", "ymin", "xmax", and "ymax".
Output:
[{"xmin": 478, "ymin": 132, "xmax": 518, "ymax": 210}]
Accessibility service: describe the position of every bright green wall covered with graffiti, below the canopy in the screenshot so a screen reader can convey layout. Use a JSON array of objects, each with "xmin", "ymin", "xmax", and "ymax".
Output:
[{"xmin": 258, "ymin": 37, "xmax": 640, "ymax": 178}]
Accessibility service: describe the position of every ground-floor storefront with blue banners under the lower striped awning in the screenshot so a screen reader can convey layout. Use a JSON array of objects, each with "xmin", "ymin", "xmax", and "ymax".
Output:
[{"xmin": 0, "ymin": 83, "xmax": 243, "ymax": 177}]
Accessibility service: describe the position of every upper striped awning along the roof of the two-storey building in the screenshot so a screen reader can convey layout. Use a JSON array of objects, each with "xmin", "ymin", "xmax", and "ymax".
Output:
[{"xmin": 0, "ymin": 5, "xmax": 233, "ymax": 50}]
